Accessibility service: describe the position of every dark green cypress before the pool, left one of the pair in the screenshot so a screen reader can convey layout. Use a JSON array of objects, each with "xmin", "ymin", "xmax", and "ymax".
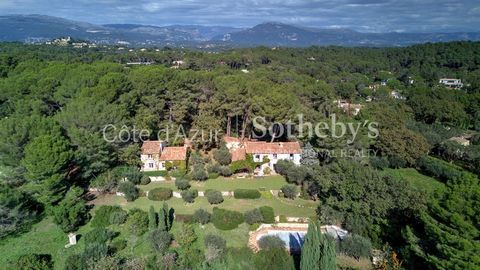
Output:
[{"xmin": 300, "ymin": 221, "xmax": 321, "ymax": 270}]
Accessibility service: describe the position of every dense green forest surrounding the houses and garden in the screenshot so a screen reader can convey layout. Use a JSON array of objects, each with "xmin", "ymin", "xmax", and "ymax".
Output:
[{"xmin": 0, "ymin": 42, "xmax": 480, "ymax": 269}]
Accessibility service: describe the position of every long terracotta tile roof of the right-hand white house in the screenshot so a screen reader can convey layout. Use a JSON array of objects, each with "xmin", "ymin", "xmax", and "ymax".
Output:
[{"xmin": 245, "ymin": 142, "xmax": 302, "ymax": 154}]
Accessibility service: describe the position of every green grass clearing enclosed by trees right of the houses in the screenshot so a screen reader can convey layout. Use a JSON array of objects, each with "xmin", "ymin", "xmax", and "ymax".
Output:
[{"xmin": 383, "ymin": 168, "xmax": 445, "ymax": 193}]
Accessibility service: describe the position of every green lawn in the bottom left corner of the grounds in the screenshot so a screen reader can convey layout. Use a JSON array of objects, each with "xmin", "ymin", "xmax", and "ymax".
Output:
[{"xmin": 0, "ymin": 217, "xmax": 89, "ymax": 269}]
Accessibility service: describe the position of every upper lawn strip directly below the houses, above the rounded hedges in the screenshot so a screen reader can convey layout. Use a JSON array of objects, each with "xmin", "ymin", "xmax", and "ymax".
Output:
[{"xmin": 139, "ymin": 175, "xmax": 287, "ymax": 191}]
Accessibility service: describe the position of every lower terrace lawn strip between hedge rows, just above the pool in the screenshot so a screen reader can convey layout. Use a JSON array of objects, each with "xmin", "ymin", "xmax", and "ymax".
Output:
[{"xmin": 95, "ymin": 195, "xmax": 318, "ymax": 217}]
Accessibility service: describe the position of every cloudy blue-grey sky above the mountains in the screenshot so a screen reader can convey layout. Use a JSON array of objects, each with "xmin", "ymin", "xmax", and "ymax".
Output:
[{"xmin": 0, "ymin": 0, "xmax": 480, "ymax": 32}]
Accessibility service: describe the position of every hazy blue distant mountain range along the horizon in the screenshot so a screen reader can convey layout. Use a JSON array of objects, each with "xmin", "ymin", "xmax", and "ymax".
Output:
[{"xmin": 0, "ymin": 15, "xmax": 480, "ymax": 47}]
